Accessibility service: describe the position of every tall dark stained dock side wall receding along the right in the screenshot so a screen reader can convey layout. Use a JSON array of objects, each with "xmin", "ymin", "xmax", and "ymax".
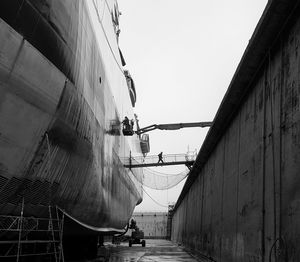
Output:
[{"xmin": 172, "ymin": 1, "xmax": 300, "ymax": 262}]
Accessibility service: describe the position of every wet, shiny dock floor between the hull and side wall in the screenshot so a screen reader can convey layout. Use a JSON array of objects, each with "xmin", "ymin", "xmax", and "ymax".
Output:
[{"xmin": 93, "ymin": 239, "xmax": 199, "ymax": 262}]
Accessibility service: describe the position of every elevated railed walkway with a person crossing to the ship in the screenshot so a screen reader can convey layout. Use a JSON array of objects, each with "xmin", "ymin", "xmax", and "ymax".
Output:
[{"xmin": 124, "ymin": 153, "xmax": 197, "ymax": 169}]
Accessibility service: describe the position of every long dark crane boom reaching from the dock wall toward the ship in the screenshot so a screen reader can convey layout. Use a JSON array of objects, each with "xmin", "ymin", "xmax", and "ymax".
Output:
[{"xmin": 136, "ymin": 122, "xmax": 212, "ymax": 135}]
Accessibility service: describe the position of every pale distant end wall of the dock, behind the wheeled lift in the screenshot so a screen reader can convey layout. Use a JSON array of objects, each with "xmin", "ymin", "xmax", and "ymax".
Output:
[{"xmin": 133, "ymin": 212, "xmax": 168, "ymax": 239}]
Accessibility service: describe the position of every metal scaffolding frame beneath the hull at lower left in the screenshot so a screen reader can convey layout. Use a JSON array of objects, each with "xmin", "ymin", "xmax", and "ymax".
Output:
[{"xmin": 0, "ymin": 200, "xmax": 64, "ymax": 262}]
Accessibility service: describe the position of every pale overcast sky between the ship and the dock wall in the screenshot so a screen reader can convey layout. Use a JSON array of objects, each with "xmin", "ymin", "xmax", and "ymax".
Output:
[{"xmin": 118, "ymin": 0, "xmax": 267, "ymax": 211}]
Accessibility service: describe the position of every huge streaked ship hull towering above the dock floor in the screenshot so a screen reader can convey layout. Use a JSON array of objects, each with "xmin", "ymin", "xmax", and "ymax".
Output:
[{"xmin": 0, "ymin": 1, "xmax": 142, "ymax": 238}]
